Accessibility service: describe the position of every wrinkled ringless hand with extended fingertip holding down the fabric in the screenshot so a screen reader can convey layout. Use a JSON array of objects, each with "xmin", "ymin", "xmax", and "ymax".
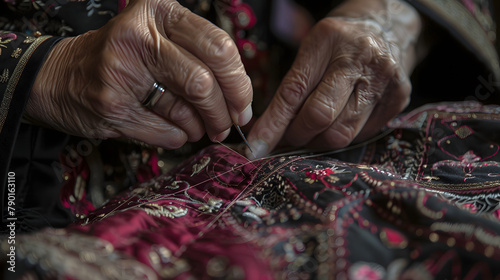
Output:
[{"xmin": 248, "ymin": 0, "xmax": 421, "ymax": 157}]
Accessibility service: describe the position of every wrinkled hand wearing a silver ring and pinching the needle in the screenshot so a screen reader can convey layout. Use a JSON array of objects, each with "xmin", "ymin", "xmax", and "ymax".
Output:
[{"xmin": 25, "ymin": 0, "xmax": 252, "ymax": 148}]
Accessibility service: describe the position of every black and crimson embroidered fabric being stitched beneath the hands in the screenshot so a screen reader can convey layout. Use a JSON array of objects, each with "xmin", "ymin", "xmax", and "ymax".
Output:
[{"xmin": 2, "ymin": 102, "xmax": 500, "ymax": 279}]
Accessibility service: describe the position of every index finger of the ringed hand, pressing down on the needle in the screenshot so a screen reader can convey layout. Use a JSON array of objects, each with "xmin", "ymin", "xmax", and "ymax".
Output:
[{"xmin": 160, "ymin": 1, "xmax": 253, "ymax": 125}]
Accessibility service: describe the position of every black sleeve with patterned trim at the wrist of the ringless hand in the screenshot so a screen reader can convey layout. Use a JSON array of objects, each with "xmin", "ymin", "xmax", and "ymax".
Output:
[{"xmin": 400, "ymin": 0, "xmax": 500, "ymax": 109}]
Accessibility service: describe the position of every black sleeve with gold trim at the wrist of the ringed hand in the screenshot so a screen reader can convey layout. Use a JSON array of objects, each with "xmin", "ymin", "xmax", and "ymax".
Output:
[{"xmin": 0, "ymin": 0, "xmax": 120, "ymax": 233}]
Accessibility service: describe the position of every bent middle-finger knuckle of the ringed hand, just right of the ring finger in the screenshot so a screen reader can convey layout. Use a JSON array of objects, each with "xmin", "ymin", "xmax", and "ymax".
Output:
[{"xmin": 185, "ymin": 67, "xmax": 215, "ymax": 101}]
